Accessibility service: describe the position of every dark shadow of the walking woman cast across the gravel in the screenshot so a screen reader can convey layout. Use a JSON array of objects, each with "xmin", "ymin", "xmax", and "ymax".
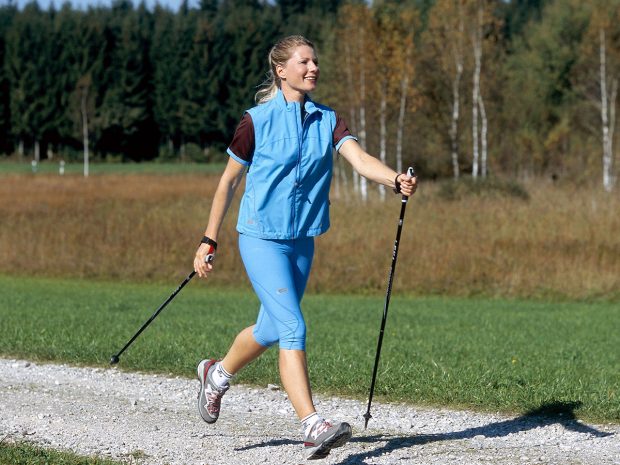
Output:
[{"xmin": 235, "ymin": 402, "xmax": 613, "ymax": 465}]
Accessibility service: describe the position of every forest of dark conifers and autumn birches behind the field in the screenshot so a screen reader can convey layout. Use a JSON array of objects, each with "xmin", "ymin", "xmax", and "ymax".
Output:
[{"xmin": 0, "ymin": 0, "xmax": 620, "ymax": 195}]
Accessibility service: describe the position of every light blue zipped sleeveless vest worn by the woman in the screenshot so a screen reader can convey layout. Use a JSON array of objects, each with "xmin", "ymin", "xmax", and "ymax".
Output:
[{"xmin": 229, "ymin": 91, "xmax": 350, "ymax": 239}]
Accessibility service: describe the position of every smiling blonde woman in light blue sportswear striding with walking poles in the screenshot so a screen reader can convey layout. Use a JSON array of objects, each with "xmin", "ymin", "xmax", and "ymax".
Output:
[{"xmin": 194, "ymin": 36, "xmax": 416, "ymax": 459}]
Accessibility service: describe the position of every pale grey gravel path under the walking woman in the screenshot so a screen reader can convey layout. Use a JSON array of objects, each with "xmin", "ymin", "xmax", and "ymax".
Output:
[{"xmin": 0, "ymin": 359, "xmax": 620, "ymax": 465}]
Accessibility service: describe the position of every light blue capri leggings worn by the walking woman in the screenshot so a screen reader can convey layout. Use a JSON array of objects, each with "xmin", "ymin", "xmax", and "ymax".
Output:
[{"xmin": 239, "ymin": 234, "xmax": 314, "ymax": 350}]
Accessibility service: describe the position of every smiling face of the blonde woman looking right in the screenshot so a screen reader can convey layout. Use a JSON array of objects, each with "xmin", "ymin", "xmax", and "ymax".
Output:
[{"xmin": 276, "ymin": 45, "xmax": 319, "ymax": 100}]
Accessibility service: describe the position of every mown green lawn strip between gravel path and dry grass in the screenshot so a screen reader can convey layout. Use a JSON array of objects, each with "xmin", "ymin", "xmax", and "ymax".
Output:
[{"xmin": 0, "ymin": 276, "xmax": 620, "ymax": 422}]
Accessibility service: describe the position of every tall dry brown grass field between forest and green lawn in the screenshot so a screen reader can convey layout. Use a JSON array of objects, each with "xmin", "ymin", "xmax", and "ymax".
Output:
[{"xmin": 0, "ymin": 174, "xmax": 620, "ymax": 299}]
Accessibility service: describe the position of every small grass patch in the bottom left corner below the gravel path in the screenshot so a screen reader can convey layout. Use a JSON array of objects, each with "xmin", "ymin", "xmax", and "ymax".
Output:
[{"xmin": 0, "ymin": 442, "xmax": 126, "ymax": 465}]
